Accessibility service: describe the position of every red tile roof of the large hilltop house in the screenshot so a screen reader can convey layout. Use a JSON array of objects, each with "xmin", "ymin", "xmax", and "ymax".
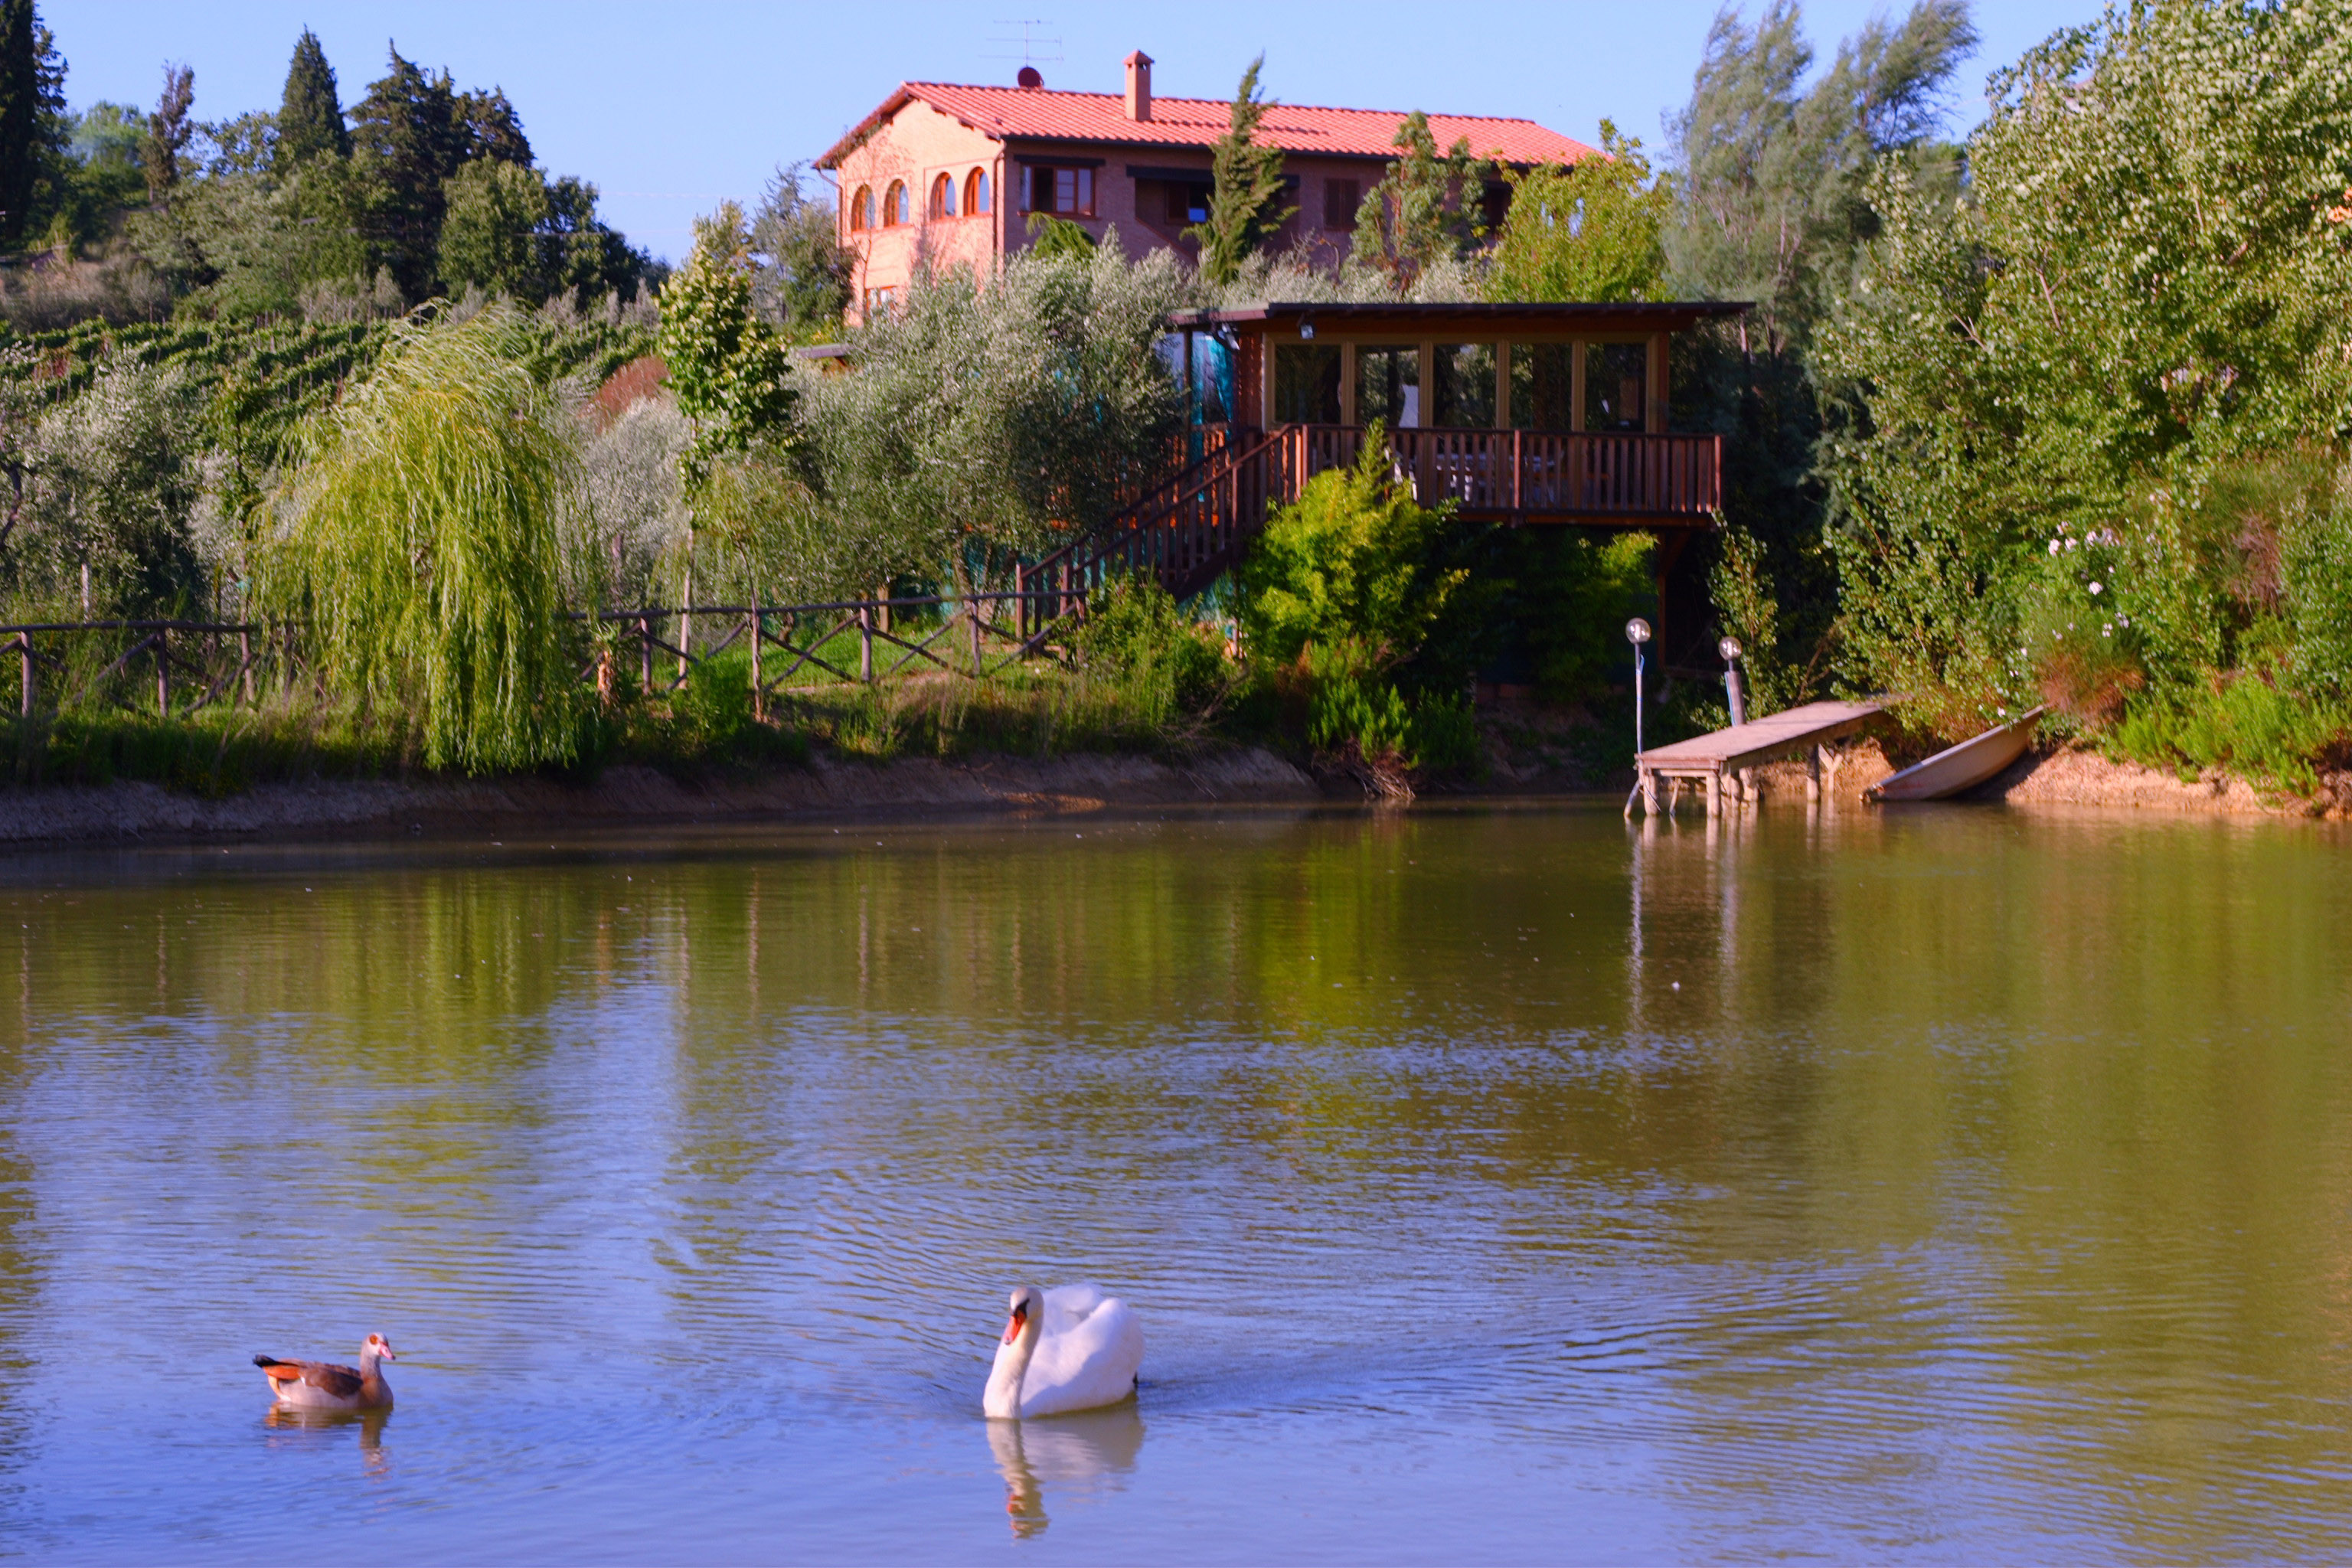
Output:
[{"xmin": 816, "ymin": 82, "xmax": 1595, "ymax": 169}]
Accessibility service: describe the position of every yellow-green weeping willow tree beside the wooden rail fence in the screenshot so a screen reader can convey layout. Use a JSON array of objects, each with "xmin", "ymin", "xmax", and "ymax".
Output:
[{"xmin": 261, "ymin": 308, "xmax": 579, "ymax": 773}]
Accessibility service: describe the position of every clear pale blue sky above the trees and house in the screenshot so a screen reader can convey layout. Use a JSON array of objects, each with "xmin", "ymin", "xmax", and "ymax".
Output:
[{"xmin": 40, "ymin": 0, "xmax": 2098, "ymax": 256}]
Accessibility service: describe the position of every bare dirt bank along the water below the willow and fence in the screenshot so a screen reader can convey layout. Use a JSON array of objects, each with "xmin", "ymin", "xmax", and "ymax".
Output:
[{"xmin": 0, "ymin": 747, "xmax": 1321, "ymax": 844}]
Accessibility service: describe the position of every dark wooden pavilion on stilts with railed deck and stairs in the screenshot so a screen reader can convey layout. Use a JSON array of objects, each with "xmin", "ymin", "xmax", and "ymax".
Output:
[{"xmin": 1023, "ymin": 301, "xmax": 1747, "ymax": 648}]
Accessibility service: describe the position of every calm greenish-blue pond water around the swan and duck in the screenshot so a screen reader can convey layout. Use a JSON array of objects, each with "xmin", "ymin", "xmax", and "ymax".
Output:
[{"xmin": 0, "ymin": 804, "xmax": 2352, "ymax": 1563}]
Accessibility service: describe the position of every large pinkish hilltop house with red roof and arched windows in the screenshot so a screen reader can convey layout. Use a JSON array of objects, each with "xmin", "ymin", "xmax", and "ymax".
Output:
[{"xmin": 816, "ymin": 49, "xmax": 1595, "ymax": 315}]
